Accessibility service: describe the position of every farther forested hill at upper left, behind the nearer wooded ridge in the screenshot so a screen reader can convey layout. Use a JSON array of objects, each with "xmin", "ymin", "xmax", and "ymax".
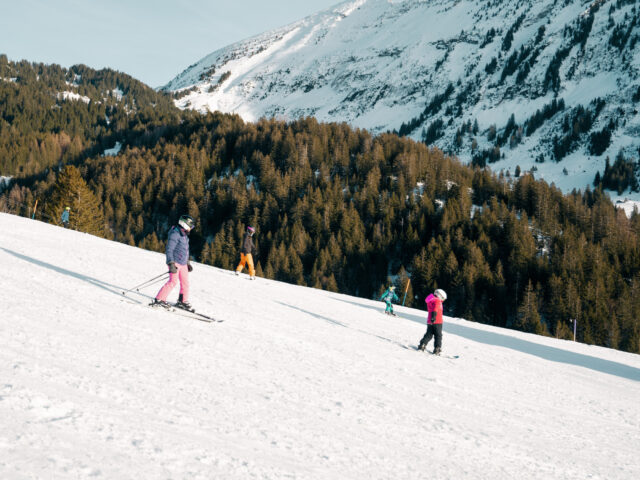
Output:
[{"xmin": 0, "ymin": 54, "xmax": 184, "ymax": 176}]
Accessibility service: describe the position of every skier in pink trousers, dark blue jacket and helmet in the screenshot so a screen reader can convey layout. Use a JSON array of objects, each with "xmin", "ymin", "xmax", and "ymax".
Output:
[{"xmin": 151, "ymin": 215, "xmax": 195, "ymax": 311}]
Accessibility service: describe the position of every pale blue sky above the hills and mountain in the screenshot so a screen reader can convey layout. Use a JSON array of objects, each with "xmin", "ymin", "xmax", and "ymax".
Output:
[{"xmin": 0, "ymin": 0, "xmax": 341, "ymax": 87}]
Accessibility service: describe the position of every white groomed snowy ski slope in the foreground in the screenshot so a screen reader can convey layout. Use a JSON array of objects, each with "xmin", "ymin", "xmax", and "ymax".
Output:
[{"xmin": 0, "ymin": 214, "xmax": 640, "ymax": 480}]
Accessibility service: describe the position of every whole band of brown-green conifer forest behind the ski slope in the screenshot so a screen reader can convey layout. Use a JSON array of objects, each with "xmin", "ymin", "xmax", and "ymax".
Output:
[{"xmin": 0, "ymin": 55, "xmax": 640, "ymax": 353}]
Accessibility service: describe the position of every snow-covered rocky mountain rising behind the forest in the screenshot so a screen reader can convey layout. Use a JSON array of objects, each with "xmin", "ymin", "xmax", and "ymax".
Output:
[{"xmin": 164, "ymin": 0, "xmax": 640, "ymax": 197}]
